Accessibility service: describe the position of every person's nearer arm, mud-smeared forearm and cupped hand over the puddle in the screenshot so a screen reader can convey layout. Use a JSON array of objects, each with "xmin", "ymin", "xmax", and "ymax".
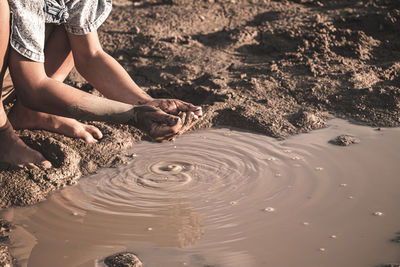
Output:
[{"xmin": 9, "ymin": 49, "xmax": 182, "ymax": 141}]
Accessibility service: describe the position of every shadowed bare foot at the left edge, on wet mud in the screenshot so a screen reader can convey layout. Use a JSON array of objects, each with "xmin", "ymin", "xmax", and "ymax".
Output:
[{"xmin": 0, "ymin": 121, "xmax": 51, "ymax": 169}]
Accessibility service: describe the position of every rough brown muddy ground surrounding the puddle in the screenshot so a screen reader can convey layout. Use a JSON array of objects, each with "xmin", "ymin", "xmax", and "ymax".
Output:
[{"xmin": 0, "ymin": 0, "xmax": 400, "ymax": 266}]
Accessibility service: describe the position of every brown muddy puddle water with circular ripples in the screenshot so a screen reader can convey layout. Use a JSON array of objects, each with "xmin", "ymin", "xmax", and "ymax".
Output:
[{"xmin": 3, "ymin": 119, "xmax": 400, "ymax": 267}]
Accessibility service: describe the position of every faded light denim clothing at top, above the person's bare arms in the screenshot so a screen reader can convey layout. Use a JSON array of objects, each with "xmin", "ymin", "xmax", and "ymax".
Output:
[{"xmin": 9, "ymin": 0, "xmax": 112, "ymax": 62}]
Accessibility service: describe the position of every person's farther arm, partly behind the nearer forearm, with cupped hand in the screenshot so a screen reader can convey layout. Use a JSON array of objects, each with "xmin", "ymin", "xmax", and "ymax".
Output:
[{"xmin": 68, "ymin": 31, "xmax": 202, "ymax": 116}]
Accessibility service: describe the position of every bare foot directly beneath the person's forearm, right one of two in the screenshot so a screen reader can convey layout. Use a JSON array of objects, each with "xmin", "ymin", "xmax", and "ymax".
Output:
[{"xmin": 8, "ymin": 101, "xmax": 103, "ymax": 143}]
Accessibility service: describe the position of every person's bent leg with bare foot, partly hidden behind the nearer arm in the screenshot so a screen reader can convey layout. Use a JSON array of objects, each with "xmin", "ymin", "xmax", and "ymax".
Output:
[{"xmin": 8, "ymin": 26, "xmax": 102, "ymax": 143}]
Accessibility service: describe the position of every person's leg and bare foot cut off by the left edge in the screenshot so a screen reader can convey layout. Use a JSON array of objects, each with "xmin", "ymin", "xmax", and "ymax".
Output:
[{"xmin": 0, "ymin": 0, "xmax": 51, "ymax": 168}]
